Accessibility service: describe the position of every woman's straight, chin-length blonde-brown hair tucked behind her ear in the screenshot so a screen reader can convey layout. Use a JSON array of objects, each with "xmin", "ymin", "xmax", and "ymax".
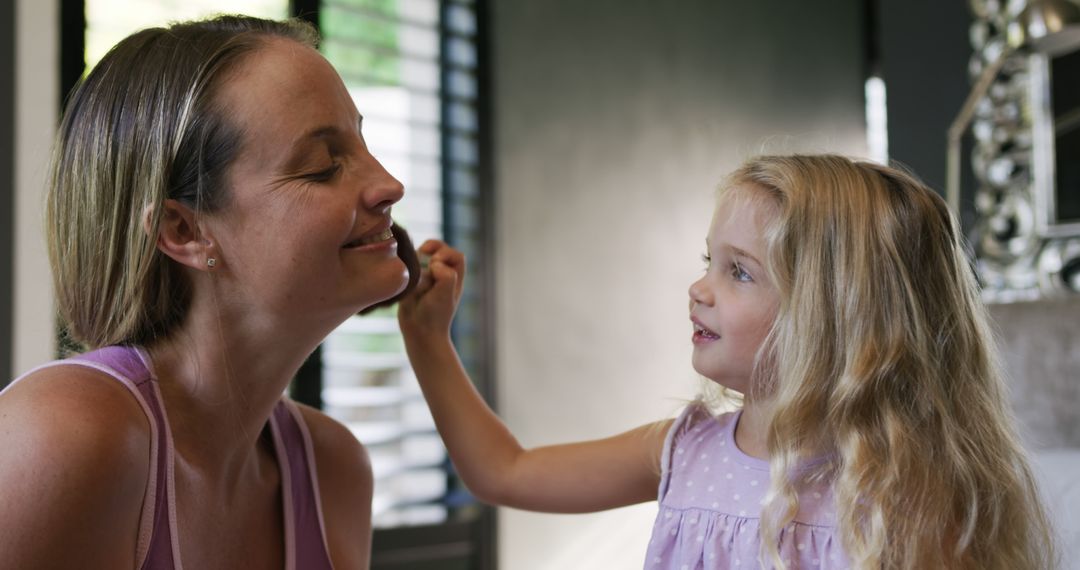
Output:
[{"xmin": 45, "ymin": 16, "xmax": 318, "ymax": 348}]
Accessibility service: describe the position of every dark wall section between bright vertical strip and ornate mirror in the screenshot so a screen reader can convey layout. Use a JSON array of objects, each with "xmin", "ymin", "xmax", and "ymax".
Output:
[{"xmin": 873, "ymin": 0, "xmax": 972, "ymax": 194}]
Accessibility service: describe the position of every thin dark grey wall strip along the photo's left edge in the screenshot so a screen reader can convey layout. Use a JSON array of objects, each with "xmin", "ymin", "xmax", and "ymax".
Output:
[{"xmin": 0, "ymin": 1, "xmax": 15, "ymax": 385}]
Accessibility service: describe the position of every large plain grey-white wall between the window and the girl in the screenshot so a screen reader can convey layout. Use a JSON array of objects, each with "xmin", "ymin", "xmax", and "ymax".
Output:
[{"xmin": 490, "ymin": 0, "xmax": 865, "ymax": 570}]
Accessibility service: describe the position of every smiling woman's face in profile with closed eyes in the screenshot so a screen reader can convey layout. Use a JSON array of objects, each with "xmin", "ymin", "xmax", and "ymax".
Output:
[{"xmin": 206, "ymin": 38, "xmax": 408, "ymax": 326}]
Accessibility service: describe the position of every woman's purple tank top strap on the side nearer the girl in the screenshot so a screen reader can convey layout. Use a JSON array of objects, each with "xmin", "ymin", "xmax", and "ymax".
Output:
[{"xmin": 270, "ymin": 397, "xmax": 333, "ymax": 570}]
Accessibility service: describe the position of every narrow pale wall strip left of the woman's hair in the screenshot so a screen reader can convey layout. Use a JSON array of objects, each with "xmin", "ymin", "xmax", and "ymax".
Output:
[{"xmin": 12, "ymin": 0, "xmax": 59, "ymax": 376}]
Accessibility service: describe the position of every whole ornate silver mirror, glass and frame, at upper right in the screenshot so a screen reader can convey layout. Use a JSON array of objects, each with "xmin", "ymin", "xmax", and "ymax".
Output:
[{"xmin": 946, "ymin": 0, "xmax": 1080, "ymax": 302}]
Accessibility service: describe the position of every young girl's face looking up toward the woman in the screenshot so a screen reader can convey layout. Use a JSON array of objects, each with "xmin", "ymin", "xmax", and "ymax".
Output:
[{"xmin": 690, "ymin": 189, "xmax": 779, "ymax": 394}]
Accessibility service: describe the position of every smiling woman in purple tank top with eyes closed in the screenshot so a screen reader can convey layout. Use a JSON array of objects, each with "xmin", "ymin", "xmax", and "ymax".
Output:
[{"xmin": 0, "ymin": 16, "xmax": 417, "ymax": 569}]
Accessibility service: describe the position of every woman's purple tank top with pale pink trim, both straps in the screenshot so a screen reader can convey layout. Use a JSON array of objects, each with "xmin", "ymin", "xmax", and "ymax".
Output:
[{"xmin": 12, "ymin": 347, "xmax": 333, "ymax": 570}]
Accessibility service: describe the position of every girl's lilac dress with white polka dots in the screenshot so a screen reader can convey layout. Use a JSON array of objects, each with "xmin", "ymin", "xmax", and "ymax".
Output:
[{"xmin": 645, "ymin": 403, "xmax": 849, "ymax": 570}]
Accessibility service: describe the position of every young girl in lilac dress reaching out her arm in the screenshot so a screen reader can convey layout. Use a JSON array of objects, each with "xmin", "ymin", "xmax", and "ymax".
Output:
[{"xmin": 400, "ymin": 155, "xmax": 1054, "ymax": 569}]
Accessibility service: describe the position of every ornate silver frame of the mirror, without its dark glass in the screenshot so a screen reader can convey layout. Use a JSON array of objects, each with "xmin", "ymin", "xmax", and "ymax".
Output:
[{"xmin": 969, "ymin": 2, "xmax": 1080, "ymax": 302}]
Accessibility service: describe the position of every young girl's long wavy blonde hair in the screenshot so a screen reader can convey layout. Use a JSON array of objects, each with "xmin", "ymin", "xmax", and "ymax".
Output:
[{"xmin": 720, "ymin": 155, "xmax": 1054, "ymax": 570}]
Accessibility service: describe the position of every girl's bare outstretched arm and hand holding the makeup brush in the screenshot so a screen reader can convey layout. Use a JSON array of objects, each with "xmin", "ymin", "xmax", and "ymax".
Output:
[{"xmin": 399, "ymin": 241, "xmax": 671, "ymax": 513}]
